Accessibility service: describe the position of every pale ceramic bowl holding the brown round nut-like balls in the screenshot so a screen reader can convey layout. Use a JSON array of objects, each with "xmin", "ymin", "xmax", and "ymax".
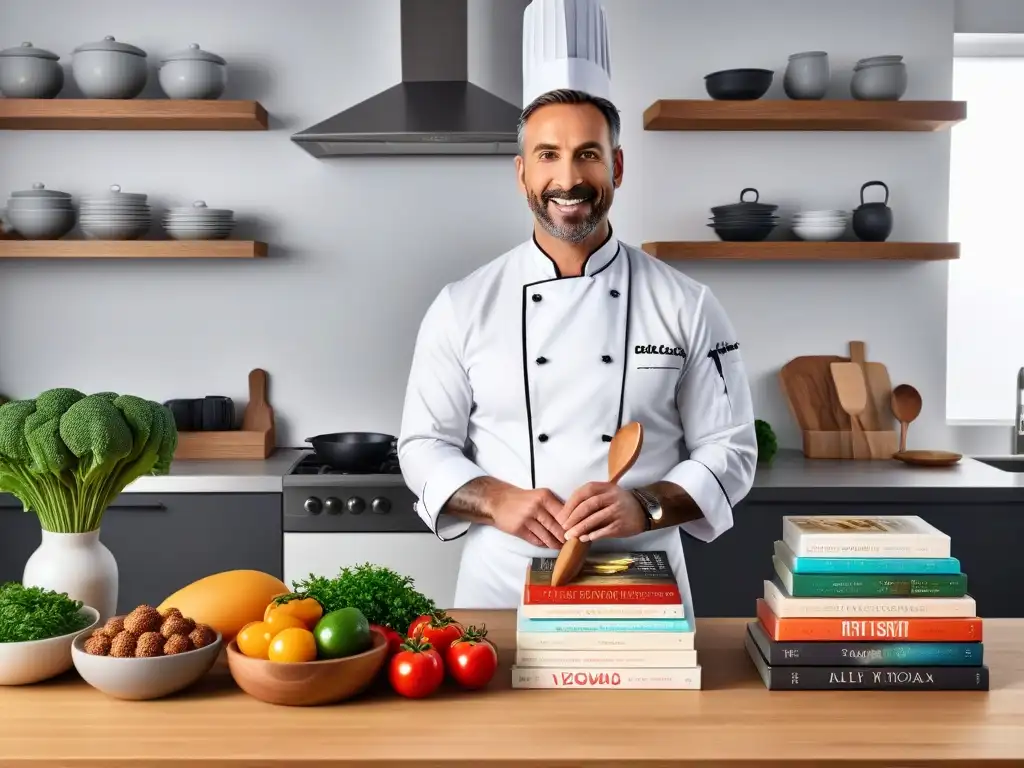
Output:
[{"xmin": 71, "ymin": 632, "xmax": 222, "ymax": 701}]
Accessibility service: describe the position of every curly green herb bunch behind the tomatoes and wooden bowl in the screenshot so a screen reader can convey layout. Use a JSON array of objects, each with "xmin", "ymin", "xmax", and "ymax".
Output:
[{"xmin": 292, "ymin": 562, "xmax": 437, "ymax": 637}]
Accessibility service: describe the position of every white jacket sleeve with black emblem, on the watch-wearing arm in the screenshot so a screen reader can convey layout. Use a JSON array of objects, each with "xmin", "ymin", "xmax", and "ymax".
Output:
[{"xmin": 664, "ymin": 288, "xmax": 758, "ymax": 542}]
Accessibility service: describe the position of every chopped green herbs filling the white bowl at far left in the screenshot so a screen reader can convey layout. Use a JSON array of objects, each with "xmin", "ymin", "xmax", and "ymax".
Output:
[{"xmin": 0, "ymin": 582, "xmax": 89, "ymax": 643}]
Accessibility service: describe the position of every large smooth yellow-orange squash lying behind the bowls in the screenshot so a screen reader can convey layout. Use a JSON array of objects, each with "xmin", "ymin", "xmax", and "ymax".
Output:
[{"xmin": 158, "ymin": 570, "xmax": 290, "ymax": 644}]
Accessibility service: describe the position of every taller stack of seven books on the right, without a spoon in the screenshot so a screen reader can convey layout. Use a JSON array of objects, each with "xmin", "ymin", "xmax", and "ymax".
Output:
[{"xmin": 744, "ymin": 515, "xmax": 988, "ymax": 690}]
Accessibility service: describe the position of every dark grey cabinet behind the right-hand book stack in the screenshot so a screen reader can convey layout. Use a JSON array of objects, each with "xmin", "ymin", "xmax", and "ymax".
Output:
[{"xmin": 683, "ymin": 499, "xmax": 1024, "ymax": 618}]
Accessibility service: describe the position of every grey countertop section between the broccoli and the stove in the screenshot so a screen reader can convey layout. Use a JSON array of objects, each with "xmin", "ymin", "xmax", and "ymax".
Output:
[{"xmin": 124, "ymin": 449, "xmax": 310, "ymax": 494}]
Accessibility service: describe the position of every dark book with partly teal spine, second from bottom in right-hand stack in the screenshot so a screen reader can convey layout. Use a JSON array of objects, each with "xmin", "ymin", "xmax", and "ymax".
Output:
[{"xmin": 745, "ymin": 622, "xmax": 984, "ymax": 667}]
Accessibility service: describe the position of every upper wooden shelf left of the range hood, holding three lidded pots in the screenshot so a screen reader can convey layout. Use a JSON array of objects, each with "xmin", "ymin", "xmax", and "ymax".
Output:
[{"xmin": 0, "ymin": 98, "xmax": 267, "ymax": 131}]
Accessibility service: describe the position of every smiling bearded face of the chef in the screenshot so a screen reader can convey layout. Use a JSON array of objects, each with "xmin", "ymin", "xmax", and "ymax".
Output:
[{"xmin": 515, "ymin": 103, "xmax": 623, "ymax": 243}]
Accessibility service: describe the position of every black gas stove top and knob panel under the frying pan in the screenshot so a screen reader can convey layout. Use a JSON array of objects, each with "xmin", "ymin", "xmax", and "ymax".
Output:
[{"xmin": 284, "ymin": 452, "xmax": 430, "ymax": 534}]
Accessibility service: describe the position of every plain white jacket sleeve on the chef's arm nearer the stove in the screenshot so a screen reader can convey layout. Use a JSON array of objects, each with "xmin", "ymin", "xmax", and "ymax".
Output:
[{"xmin": 397, "ymin": 288, "xmax": 486, "ymax": 541}]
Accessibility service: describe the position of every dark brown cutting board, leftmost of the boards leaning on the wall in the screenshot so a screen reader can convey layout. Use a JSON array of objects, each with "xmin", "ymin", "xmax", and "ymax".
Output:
[{"xmin": 778, "ymin": 354, "xmax": 850, "ymax": 432}]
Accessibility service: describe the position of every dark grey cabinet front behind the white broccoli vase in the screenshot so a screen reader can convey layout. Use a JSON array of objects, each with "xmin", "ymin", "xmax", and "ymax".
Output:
[{"xmin": 0, "ymin": 494, "xmax": 284, "ymax": 612}]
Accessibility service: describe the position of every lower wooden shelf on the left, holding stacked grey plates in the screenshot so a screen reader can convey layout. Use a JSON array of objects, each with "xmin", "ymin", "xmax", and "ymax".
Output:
[{"xmin": 0, "ymin": 240, "xmax": 267, "ymax": 259}]
